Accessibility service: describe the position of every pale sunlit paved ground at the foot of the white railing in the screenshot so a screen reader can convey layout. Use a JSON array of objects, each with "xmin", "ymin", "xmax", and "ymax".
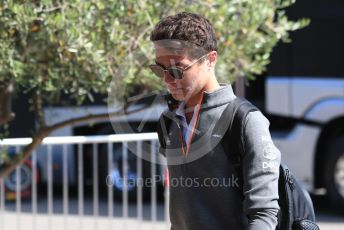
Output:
[{"xmin": 0, "ymin": 198, "xmax": 169, "ymax": 230}]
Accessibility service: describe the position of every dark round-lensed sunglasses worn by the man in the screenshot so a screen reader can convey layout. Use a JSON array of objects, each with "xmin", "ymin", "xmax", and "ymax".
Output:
[{"xmin": 149, "ymin": 54, "xmax": 208, "ymax": 80}]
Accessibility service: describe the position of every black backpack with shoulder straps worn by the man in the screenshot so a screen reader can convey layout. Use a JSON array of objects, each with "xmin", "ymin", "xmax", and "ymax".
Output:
[{"xmin": 158, "ymin": 97, "xmax": 319, "ymax": 230}]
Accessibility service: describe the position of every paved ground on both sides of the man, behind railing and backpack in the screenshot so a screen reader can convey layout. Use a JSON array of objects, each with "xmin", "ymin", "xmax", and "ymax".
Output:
[{"xmin": 0, "ymin": 194, "xmax": 344, "ymax": 230}]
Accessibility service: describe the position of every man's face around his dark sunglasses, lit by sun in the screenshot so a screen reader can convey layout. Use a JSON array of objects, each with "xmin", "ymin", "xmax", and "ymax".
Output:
[{"xmin": 155, "ymin": 47, "xmax": 208, "ymax": 101}]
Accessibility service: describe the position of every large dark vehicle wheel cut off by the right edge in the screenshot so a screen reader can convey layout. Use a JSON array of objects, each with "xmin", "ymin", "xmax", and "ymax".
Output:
[{"xmin": 324, "ymin": 136, "xmax": 344, "ymax": 210}]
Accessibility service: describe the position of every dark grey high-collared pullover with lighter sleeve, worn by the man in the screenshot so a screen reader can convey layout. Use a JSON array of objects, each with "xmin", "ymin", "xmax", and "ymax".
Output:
[{"xmin": 158, "ymin": 84, "xmax": 281, "ymax": 230}]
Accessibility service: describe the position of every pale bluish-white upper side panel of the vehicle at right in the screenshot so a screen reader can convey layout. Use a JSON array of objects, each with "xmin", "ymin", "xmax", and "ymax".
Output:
[{"xmin": 265, "ymin": 77, "xmax": 344, "ymax": 118}]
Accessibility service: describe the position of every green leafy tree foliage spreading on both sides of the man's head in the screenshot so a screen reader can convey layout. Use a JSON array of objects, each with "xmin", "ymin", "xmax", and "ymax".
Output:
[{"xmin": 0, "ymin": 0, "xmax": 308, "ymax": 109}]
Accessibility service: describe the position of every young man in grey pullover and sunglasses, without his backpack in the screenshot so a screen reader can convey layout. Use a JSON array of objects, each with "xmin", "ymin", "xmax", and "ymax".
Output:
[{"xmin": 150, "ymin": 12, "xmax": 280, "ymax": 230}]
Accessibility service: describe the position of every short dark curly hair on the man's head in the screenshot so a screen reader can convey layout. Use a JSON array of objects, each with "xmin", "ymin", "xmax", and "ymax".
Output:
[{"xmin": 150, "ymin": 12, "xmax": 217, "ymax": 58}]
